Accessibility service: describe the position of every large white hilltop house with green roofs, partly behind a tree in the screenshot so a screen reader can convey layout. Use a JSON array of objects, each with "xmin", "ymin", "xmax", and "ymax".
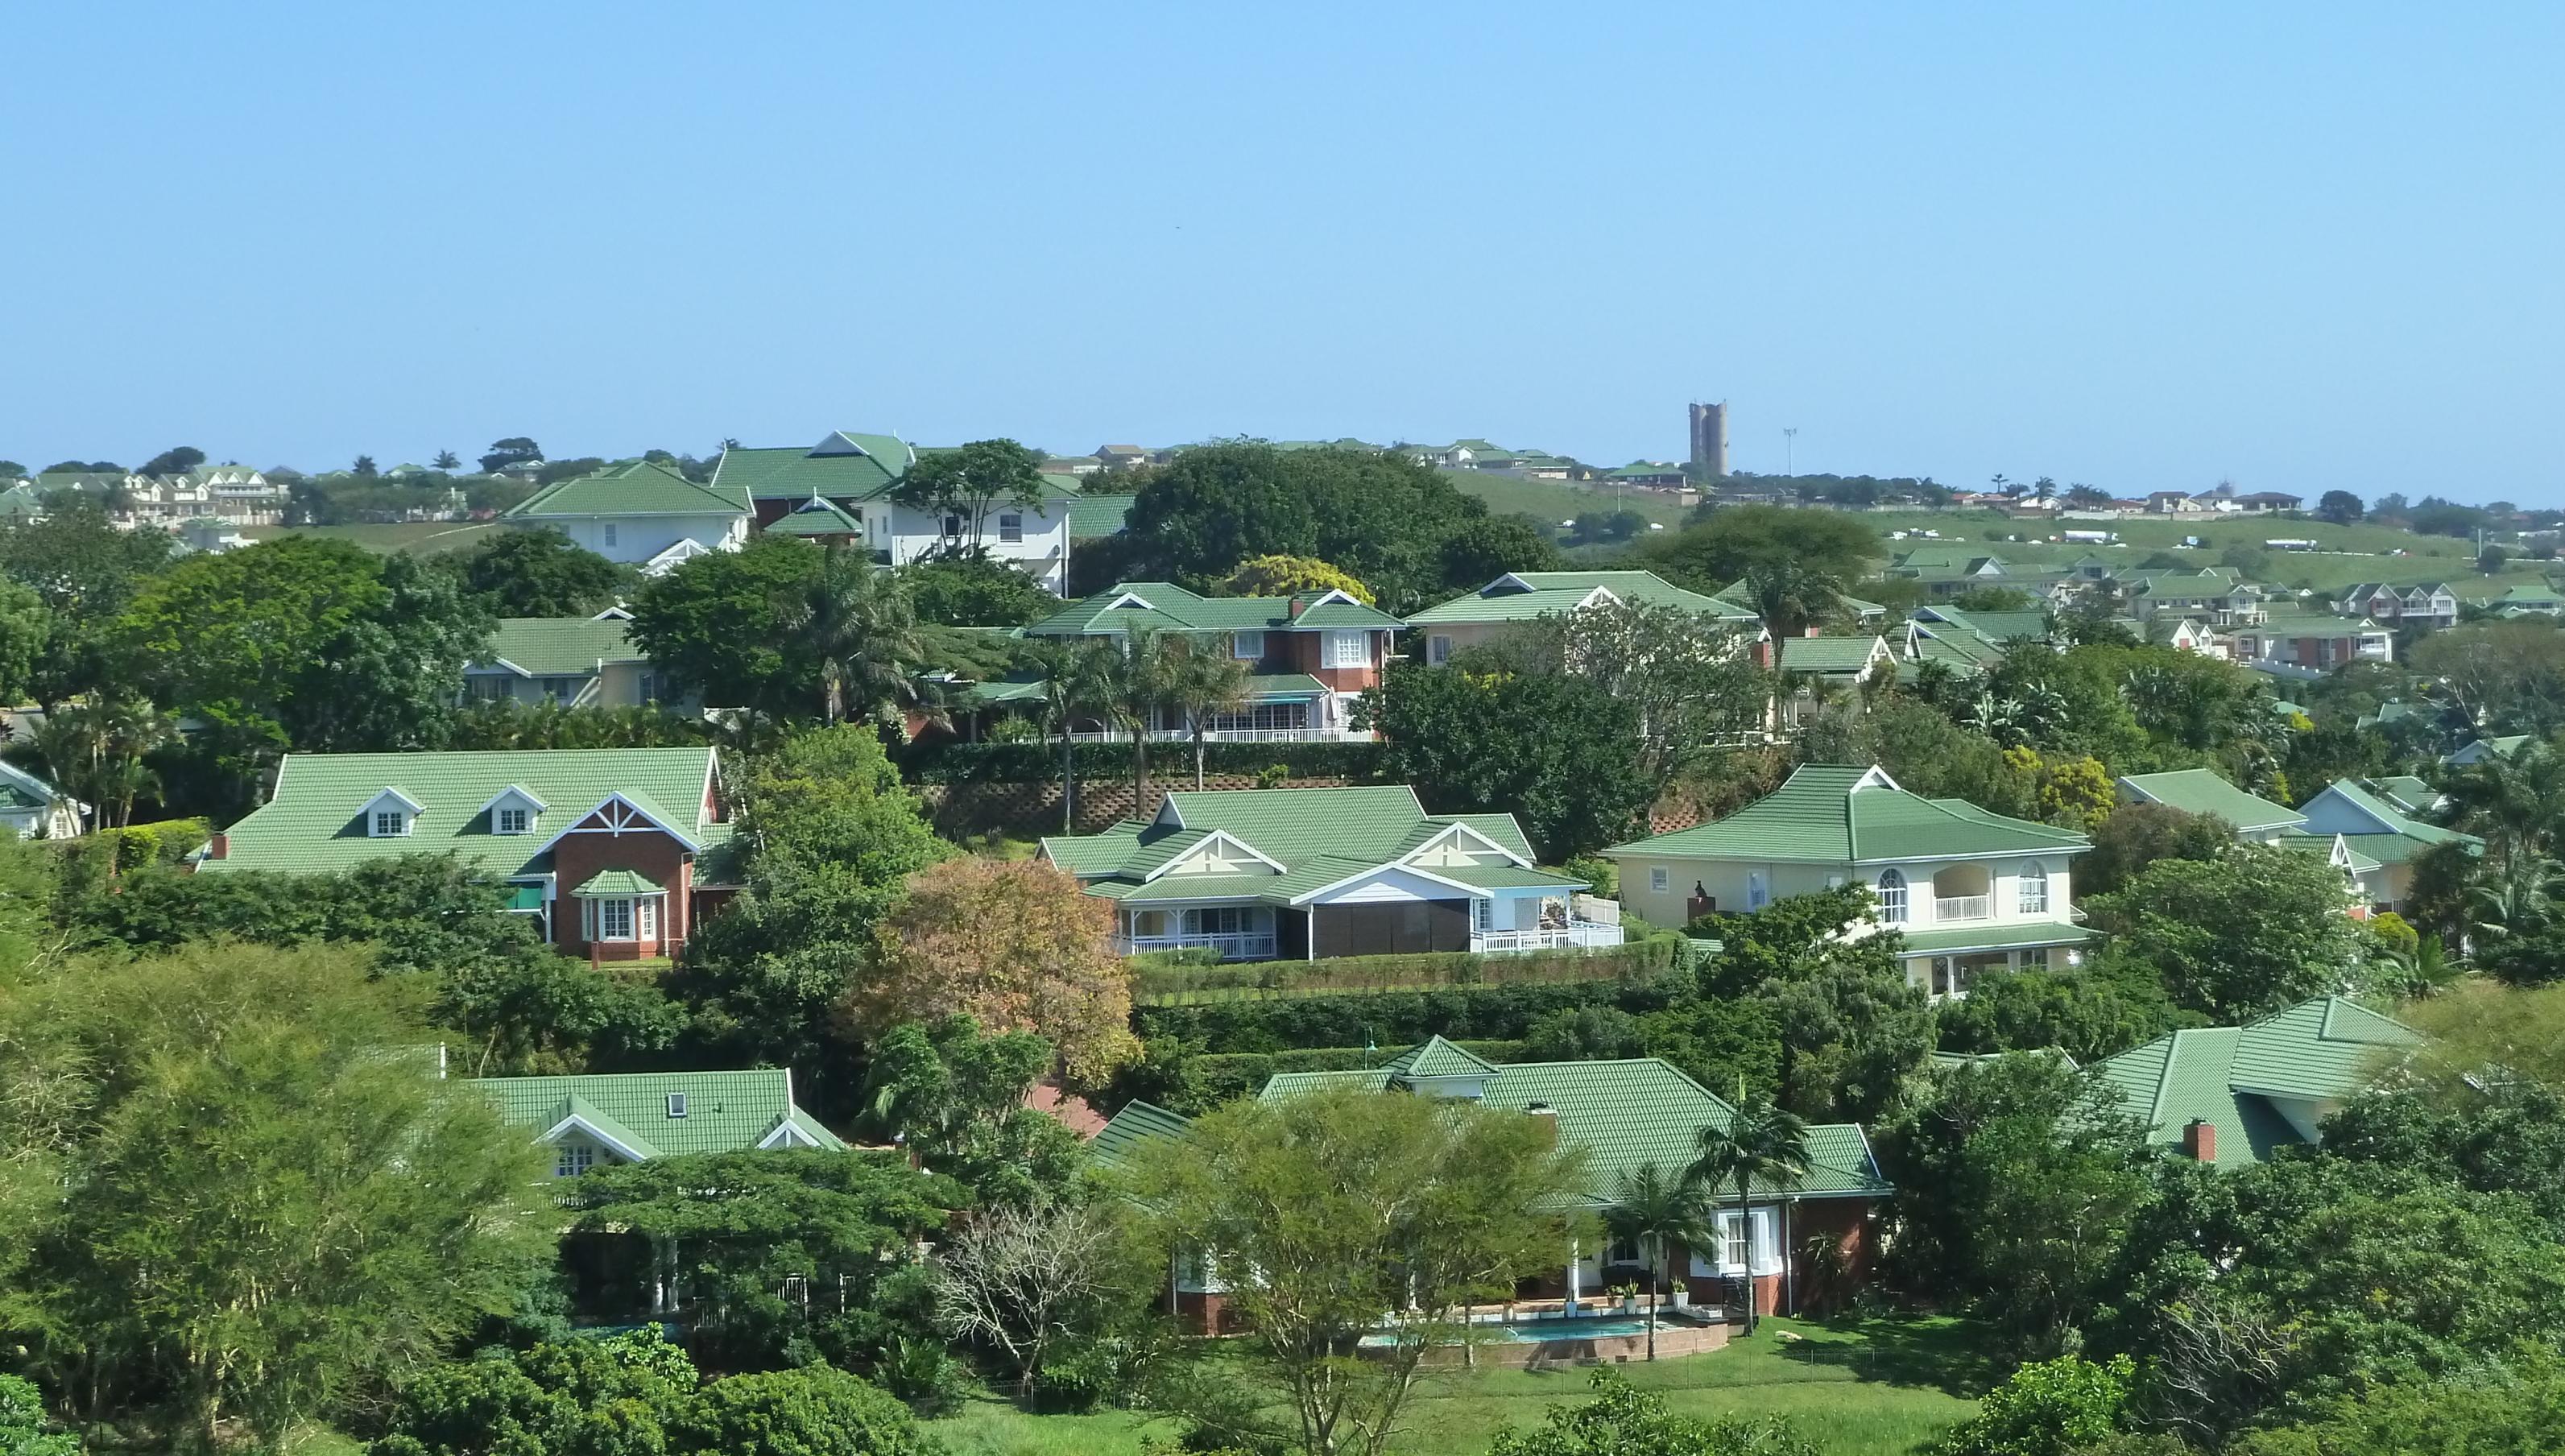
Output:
[{"xmin": 713, "ymin": 431, "xmax": 1082, "ymax": 592}]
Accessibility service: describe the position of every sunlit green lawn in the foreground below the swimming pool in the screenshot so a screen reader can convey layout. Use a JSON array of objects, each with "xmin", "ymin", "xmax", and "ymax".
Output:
[{"xmin": 933, "ymin": 1320, "xmax": 1993, "ymax": 1456}]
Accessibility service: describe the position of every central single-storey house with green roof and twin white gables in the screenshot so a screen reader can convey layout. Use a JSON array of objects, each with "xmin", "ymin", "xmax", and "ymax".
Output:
[{"xmin": 1041, "ymin": 784, "xmax": 1621, "ymax": 962}]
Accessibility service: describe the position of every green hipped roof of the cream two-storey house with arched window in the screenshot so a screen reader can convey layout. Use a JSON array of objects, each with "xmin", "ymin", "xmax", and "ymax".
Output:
[{"xmin": 1603, "ymin": 764, "xmax": 2091, "ymax": 864}]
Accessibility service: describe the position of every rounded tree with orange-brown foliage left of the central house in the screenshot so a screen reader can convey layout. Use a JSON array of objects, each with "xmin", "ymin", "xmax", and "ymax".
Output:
[{"xmin": 849, "ymin": 856, "xmax": 1139, "ymax": 1084}]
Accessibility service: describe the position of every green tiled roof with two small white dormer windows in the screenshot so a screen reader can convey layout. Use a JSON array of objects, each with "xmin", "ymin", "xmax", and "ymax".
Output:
[{"xmin": 200, "ymin": 748, "xmax": 731, "ymax": 879}]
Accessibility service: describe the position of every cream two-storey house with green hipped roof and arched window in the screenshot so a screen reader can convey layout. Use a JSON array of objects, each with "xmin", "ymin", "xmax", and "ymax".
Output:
[{"xmin": 1603, "ymin": 764, "xmax": 2093, "ymax": 999}]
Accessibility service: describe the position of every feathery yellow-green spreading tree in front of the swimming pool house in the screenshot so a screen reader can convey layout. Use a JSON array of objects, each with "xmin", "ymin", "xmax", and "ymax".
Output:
[{"xmin": 1123, "ymin": 1087, "xmax": 1582, "ymax": 1456}]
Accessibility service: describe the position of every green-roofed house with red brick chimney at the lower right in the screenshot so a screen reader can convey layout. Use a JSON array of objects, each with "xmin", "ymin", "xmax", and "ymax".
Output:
[{"xmin": 2095, "ymin": 997, "xmax": 2422, "ymax": 1169}]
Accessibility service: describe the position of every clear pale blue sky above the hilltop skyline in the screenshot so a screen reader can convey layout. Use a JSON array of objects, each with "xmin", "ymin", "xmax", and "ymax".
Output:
[{"xmin": 0, "ymin": 2, "xmax": 2565, "ymax": 505}]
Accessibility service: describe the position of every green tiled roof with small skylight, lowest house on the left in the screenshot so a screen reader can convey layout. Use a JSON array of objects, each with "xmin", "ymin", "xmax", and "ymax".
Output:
[{"xmin": 470, "ymin": 1066, "xmax": 846, "ymax": 1159}]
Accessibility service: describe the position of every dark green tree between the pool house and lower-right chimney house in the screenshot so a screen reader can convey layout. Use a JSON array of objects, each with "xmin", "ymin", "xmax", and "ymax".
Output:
[{"xmin": 1877, "ymin": 1051, "xmax": 2149, "ymax": 1354}]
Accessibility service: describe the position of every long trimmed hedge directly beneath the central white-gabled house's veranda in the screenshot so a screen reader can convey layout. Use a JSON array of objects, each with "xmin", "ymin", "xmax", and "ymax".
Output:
[{"xmin": 1131, "ymin": 936, "xmax": 1688, "ymax": 1005}]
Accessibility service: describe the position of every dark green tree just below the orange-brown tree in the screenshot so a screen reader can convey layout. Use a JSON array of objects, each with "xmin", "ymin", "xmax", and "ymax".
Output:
[{"xmin": 864, "ymin": 1015, "xmax": 1080, "ymax": 1207}]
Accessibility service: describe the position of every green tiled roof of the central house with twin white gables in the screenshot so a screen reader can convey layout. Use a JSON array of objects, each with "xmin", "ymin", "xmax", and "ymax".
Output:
[{"xmin": 1041, "ymin": 784, "xmax": 1549, "ymax": 905}]
